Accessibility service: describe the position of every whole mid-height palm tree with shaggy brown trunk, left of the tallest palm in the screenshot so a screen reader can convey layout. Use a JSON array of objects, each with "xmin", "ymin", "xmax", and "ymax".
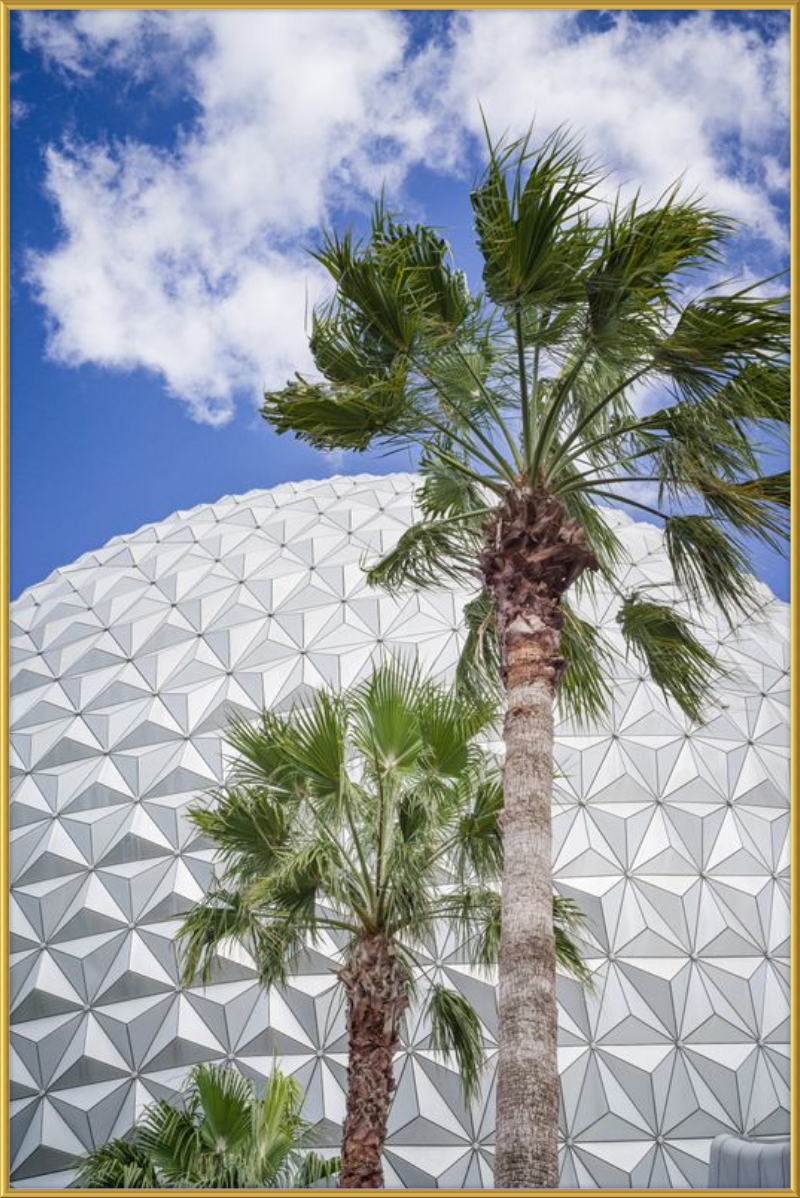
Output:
[{"xmin": 178, "ymin": 661, "xmax": 586, "ymax": 1188}]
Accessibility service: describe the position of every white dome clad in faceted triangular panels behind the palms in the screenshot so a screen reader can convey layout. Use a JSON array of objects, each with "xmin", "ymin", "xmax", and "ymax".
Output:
[{"xmin": 11, "ymin": 474, "xmax": 789, "ymax": 1188}]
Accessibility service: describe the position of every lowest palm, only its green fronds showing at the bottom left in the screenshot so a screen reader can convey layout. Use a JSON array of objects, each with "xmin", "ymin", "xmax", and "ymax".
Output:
[{"xmin": 75, "ymin": 1065, "xmax": 339, "ymax": 1190}]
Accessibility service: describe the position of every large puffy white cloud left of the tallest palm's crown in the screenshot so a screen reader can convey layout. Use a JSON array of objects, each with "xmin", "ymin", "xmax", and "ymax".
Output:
[{"xmin": 26, "ymin": 12, "xmax": 443, "ymax": 422}]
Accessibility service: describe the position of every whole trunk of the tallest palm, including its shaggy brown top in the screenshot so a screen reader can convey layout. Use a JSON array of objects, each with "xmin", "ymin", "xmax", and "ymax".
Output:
[{"xmin": 481, "ymin": 489, "xmax": 596, "ymax": 1190}]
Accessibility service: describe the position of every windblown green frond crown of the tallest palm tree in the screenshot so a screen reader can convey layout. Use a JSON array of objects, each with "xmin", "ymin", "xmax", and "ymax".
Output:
[{"xmin": 262, "ymin": 132, "xmax": 789, "ymax": 718}]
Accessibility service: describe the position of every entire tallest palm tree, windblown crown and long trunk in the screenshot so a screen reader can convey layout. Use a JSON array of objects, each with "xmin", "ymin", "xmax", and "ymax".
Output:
[{"xmin": 262, "ymin": 132, "xmax": 789, "ymax": 1187}]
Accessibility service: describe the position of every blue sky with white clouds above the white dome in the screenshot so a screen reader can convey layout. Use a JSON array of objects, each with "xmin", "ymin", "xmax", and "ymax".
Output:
[{"xmin": 11, "ymin": 10, "xmax": 789, "ymax": 598}]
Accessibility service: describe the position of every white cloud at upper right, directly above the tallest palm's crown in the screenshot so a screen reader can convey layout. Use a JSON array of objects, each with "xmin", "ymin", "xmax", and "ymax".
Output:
[{"xmin": 444, "ymin": 10, "xmax": 789, "ymax": 242}]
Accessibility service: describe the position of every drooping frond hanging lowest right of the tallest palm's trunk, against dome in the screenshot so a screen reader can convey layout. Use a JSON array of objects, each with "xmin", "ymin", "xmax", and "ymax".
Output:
[{"xmin": 617, "ymin": 592, "xmax": 721, "ymax": 720}]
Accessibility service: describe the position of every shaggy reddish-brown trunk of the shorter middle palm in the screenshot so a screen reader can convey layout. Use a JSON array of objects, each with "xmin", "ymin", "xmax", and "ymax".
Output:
[{"xmin": 339, "ymin": 936, "xmax": 408, "ymax": 1190}]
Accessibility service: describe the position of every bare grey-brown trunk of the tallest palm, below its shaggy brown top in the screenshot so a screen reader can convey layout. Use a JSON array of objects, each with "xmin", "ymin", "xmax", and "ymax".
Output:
[{"xmin": 495, "ymin": 625, "xmax": 558, "ymax": 1190}]
